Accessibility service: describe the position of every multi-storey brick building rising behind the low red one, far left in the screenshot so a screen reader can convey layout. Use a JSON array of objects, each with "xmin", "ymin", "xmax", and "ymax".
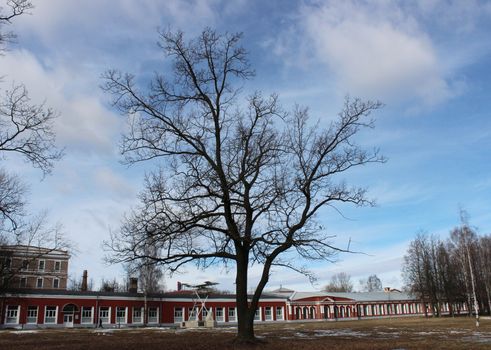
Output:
[{"xmin": 0, "ymin": 245, "xmax": 70, "ymax": 290}]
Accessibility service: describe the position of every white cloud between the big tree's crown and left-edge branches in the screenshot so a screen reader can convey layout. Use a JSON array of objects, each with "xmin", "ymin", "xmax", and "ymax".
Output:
[{"xmin": 0, "ymin": 50, "xmax": 123, "ymax": 154}]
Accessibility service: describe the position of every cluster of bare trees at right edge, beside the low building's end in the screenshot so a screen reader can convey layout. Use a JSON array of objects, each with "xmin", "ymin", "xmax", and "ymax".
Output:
[{"xmin": 403, "ymin": 216, "xmax": 491, "ymax": 316}]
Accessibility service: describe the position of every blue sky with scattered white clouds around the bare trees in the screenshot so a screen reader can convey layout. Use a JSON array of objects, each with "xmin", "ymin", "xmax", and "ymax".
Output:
[{"xmin": 0, "ymin": 0, "xmax": 491, "ymax": 290}]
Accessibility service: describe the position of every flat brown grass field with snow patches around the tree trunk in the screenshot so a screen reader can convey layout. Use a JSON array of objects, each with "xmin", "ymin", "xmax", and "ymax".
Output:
[{"xmin": 0, "ymin": 317, "xmax": 491, "ymax": 350}]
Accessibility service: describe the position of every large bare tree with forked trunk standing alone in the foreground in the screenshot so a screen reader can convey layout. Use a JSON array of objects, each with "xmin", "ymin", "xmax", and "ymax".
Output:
[{"xmin": 103, "ymin": 29, "xmax": 384, "ymax": 342}]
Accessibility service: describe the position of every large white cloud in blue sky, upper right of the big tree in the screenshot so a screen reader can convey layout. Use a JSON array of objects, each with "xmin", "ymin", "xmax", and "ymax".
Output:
[{"xmin": 301, "ymin": 2, "xmax": 454, "ymax": 104}]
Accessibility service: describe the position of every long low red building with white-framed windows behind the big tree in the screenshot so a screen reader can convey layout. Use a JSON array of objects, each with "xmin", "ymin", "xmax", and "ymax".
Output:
[{"xmin": 0, "ymin": 290, "xmax": 467, "ymax": 328}]
